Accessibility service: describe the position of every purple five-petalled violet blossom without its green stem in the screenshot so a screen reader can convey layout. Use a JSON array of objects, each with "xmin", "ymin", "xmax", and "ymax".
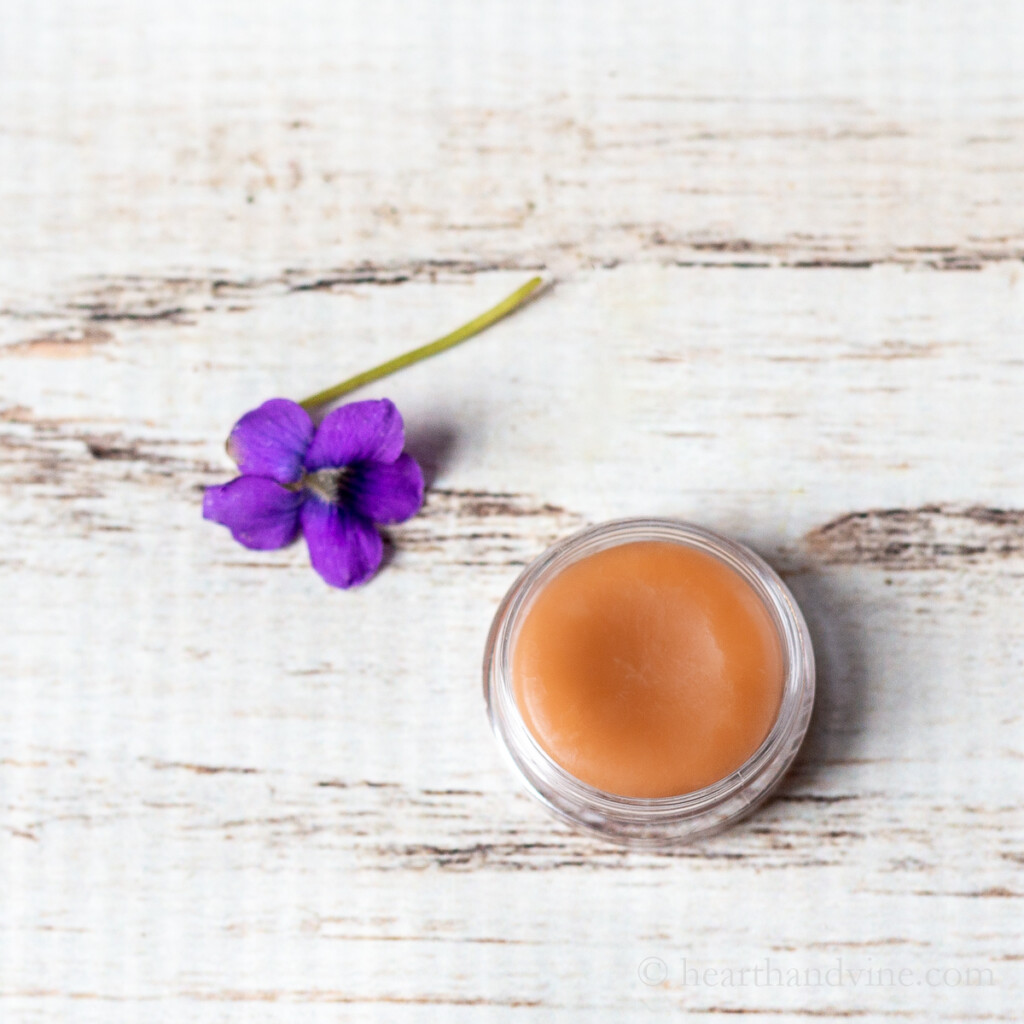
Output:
[{"xmin": 203, "ymin": 398, "xmax": 423, "ymax": 588}]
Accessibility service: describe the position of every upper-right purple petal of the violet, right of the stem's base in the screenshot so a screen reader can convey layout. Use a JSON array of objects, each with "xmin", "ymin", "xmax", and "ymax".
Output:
[{"xmin": 306, "ymin": 398, "xmax": 406, "ymax": 472}]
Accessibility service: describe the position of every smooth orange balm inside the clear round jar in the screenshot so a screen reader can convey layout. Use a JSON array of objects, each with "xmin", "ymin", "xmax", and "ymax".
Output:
[{"xmin": 512, "ymin": 541, "xmax": 784, "ymax": 798}]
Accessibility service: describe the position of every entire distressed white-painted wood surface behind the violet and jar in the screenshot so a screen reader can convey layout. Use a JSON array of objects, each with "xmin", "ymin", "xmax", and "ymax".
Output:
[{"xmin": 0, "ymin": 0, "xmax": 1024, "ymax": 1024}]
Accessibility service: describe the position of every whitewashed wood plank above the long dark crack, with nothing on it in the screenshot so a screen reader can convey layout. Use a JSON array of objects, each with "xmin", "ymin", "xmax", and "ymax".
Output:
[{"xmin": 0, "ymin": 0, "xmax": 1024, "ymax": 305}]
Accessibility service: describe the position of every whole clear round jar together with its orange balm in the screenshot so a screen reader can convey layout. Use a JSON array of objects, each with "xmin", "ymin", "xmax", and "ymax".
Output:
[{"xmin": 484, "ymin": 519, "xmax": 814, "ymax": 845}]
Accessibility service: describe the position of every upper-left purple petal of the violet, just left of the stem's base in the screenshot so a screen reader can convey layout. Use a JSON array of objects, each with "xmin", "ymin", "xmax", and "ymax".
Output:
[{"xmin": 227, "ymin": 398, "xmax": 313, "ymax": 483}]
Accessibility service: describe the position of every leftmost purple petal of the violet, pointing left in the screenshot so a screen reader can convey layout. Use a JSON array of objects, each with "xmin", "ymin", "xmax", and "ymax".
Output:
[{"xmin": 203, "ymin": 476, "xmax": 304, "ymax": 551}]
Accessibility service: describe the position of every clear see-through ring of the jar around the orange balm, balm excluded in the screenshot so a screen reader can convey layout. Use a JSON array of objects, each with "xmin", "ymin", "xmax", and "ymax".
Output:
[{"xmin": 483, "ymin": 519, "xmax": 814, "ymax": 847}]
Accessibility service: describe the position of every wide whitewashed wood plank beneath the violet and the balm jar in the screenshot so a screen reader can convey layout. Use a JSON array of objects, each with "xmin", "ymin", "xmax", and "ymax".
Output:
[{"xmin": 0, "ymin": 267, "xmax": 1024, "ymax": 1020}]
